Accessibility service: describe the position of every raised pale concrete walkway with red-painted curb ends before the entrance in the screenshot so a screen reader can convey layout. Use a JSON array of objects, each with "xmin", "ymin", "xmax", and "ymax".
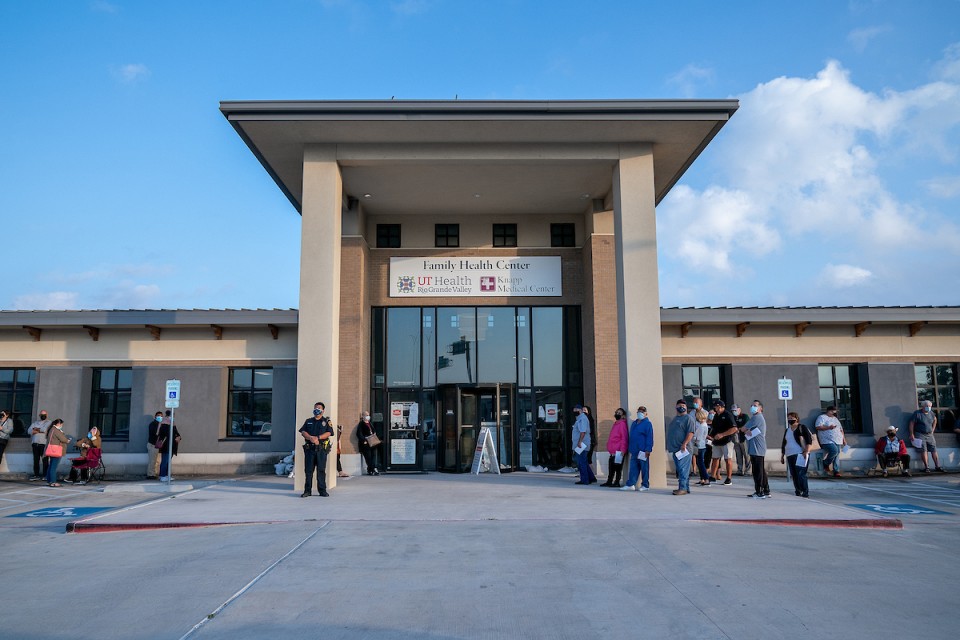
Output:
[{"xmin": 74, "ymin": 473, "xmax": 897, "ymax": 531}]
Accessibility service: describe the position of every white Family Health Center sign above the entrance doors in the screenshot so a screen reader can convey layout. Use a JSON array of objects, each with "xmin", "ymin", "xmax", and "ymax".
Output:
[{"xmin": 390, "ymin": 256, "xmax": 563, "ymax": 298}]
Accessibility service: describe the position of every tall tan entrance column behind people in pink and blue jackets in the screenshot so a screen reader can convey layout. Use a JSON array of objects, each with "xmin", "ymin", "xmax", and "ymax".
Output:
[{"xmin": 613, "ymin": 143, "xmax": 667, "ymax": 488}]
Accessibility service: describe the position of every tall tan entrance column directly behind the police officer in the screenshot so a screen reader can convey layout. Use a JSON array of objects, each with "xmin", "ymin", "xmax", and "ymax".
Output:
[{"xmin": 294, "ymin": 145, "xmax": 343, "ymax": 491}]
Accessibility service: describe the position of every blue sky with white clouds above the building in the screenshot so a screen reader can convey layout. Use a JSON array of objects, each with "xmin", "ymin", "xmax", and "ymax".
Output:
[{"xmin": 0, "ymin": 0, "xmax": 960, "ymax": 309}]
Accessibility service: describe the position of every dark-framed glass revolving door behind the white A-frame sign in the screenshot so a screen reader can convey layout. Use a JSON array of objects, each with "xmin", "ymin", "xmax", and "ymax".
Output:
[{"xmin": 438, "ymin": 384, "xmax": 516, "ymax": 473}]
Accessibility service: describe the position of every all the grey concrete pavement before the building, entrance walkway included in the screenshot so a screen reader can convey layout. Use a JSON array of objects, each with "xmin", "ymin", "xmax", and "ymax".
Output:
[{"xmin": 0, "ymin": 473, "xmax": 960, "ymax": 640}]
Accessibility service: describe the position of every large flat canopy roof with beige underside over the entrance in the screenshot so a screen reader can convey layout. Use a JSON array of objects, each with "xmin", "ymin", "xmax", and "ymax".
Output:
[{"xmin": 220, "ymin": 100, "xmax": 738, "ymax": 214}]
